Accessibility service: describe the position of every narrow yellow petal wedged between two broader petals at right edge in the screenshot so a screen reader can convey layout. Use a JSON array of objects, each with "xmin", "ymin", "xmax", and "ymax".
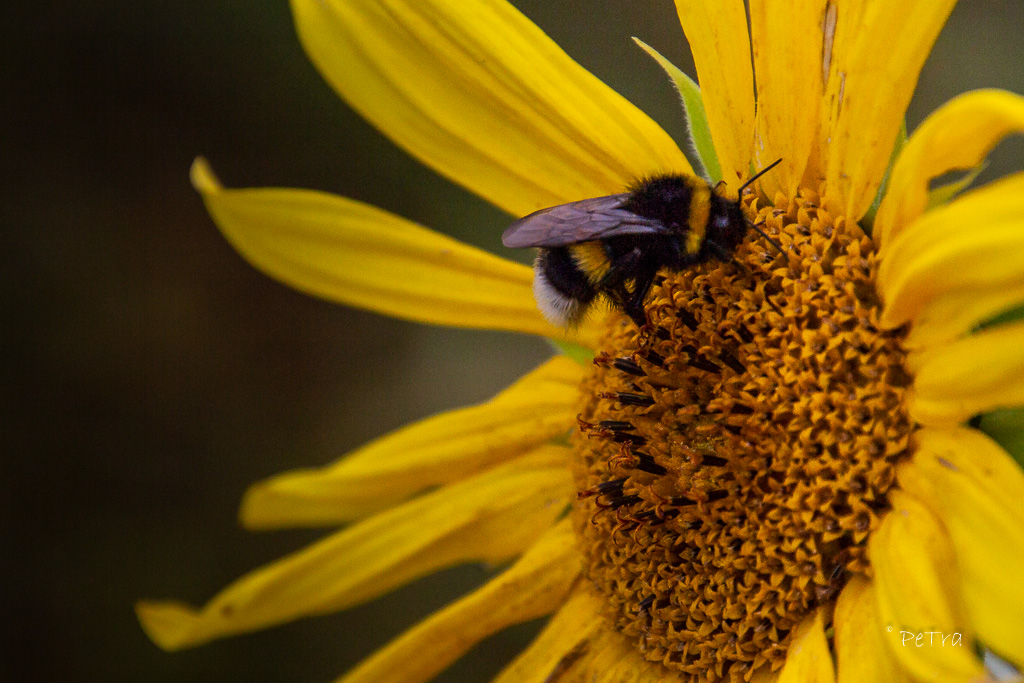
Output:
[{"xmin": 903, "ymin": 280, "xmax": 1024, "ymax": 350}]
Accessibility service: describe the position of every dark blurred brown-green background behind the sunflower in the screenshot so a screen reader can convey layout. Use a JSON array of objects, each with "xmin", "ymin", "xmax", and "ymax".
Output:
[{"xmin": 8, "ymin": 0, "xmax": 1024, "ymax": 683}]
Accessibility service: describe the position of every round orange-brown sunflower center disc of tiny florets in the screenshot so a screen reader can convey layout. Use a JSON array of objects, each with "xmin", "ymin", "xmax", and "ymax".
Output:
[{"xmin": 574, "ymin": 191, "xmax": 912, "ymax": 681}]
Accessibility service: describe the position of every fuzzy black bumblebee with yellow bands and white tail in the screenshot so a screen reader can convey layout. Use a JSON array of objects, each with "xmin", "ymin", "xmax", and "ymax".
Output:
[{"xmin": 502, "ymin": 159, "xmax": 782, "ymax": 327}]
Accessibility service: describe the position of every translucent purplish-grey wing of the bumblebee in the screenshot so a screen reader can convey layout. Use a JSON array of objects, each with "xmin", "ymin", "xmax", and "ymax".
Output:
[{"xmin": 502, "ymin": 194, "xmax": 668, "ymax": 248}]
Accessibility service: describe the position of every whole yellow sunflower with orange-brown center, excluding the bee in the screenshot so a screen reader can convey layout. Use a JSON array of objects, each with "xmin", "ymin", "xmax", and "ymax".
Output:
[{"xmin": 138, "ymin": 0, "xmax": 1024, "ymax": 682}]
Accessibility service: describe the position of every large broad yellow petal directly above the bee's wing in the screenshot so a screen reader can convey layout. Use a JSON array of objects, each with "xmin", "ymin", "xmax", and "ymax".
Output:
[{"xmin": 292, "ymin": 0, "xmax": 691, "ymax": 215}]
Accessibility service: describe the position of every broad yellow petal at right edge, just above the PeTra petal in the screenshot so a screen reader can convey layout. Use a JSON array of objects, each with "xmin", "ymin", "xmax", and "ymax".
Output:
[{"xmin": 899, "ymin": 427, "xmax": 1024, "ymax": 666}]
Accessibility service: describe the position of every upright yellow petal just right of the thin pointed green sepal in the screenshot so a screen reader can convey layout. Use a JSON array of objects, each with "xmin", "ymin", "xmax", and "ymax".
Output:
[{"xmin": 676, "ymin": 0, "xmax": 757, "ymax": 184}]
